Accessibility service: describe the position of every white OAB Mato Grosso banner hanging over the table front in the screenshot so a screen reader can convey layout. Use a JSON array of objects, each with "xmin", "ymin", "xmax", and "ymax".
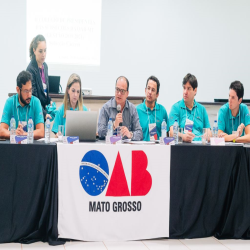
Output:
[{"xmin": 57, "ymin": 143, "xmax": 170, "ymax": 241}]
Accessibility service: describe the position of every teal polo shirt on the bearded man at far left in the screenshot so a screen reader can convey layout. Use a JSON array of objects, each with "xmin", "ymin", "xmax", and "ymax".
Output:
[{"xmin": 1, "ymin": 94, "xmax": 44, "ymax": 129}]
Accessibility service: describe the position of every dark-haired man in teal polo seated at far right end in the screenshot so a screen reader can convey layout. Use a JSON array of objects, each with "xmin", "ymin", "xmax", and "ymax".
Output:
[{"xmin": 218, "ymin": 81, "xmax": 250, "ymax": 143}]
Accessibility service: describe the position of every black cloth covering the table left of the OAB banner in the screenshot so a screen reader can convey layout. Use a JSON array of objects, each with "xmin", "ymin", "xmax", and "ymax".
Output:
[{"xmin": 0, "ymin": 141, "xmax": 60, "ymax": 245}]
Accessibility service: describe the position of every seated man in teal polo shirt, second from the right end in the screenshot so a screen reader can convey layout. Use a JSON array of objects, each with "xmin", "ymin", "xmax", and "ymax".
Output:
[{"xmin": 169, "ymin": 74, "xmax": 212, "ymax": 142}]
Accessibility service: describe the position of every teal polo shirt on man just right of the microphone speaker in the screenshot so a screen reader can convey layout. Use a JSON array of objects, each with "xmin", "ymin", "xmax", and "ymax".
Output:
[{"xmin": 136, "ymin": 100, "xmax": 169, "ymax": 141}]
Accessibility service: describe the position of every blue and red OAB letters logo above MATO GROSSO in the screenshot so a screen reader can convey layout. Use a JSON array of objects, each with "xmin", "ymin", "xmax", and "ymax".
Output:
[{"xmin": 79, "ymin": 150, "xmax": 152, "ymax": 197}]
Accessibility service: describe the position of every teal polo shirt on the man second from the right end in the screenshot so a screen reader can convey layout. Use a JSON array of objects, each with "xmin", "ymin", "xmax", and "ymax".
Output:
[{"xmin": 169, "ymin": 99, "xmax": 210, "ymax": 141}]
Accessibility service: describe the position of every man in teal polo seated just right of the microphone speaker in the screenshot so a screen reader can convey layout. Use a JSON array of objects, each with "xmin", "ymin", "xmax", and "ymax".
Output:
[{"xmin": 136, "ymin": 76, "xmax": 169, "ymax": 141}]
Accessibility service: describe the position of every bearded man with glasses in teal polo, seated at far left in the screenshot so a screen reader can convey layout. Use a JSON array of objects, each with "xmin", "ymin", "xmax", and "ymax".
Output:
[{"xmin": 0, "ymin": 71, "xmax": 44, "ymax": 140}]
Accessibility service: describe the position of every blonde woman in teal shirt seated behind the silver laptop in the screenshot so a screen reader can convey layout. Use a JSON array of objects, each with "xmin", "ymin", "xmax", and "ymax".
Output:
[{"xmin": 52, "ymin": 74, "xmax": 88, "ymax": 135}]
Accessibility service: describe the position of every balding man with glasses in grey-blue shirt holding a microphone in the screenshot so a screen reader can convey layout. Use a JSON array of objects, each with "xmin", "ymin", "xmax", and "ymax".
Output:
[{"xmin": 98, "ymin": 76, "xmax": 143, "ymax": 141}]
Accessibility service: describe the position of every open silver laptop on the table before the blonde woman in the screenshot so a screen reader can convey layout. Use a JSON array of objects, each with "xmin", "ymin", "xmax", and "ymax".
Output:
[{"xmin": 66, "ymin": 110, "xmax": 97, "ymax": 141}]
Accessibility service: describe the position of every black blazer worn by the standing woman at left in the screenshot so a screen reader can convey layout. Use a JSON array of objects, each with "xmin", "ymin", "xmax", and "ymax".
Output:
[{"xmin": 26, "ymin": 56, "xmax": 51, "ymax": 119}]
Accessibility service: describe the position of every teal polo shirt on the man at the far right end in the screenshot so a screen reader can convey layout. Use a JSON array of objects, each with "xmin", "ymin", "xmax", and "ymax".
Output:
[{"xmin": 218, "ymin": 103, "xmax": 250, "ymax": 136}]
